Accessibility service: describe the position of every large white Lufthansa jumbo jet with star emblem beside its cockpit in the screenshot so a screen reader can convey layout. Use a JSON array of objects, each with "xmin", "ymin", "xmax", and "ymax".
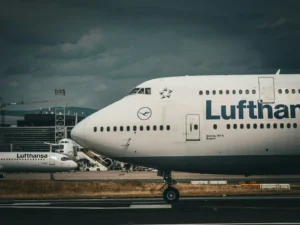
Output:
[{"xmin": 71, "ymin": 70, "xmax": 300, "ymax": 202}]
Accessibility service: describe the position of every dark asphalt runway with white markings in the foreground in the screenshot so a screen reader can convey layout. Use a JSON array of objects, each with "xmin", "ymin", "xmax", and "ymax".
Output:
[{"xmin": 0, "ymin": 196, "xmax": 300, "ymax": 225}]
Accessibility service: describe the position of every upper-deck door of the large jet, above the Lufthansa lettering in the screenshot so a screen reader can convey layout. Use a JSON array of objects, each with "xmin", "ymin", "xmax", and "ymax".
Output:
[{"xmin": 258, "ymin": 77, "xmax": 275, "ymax": 103}]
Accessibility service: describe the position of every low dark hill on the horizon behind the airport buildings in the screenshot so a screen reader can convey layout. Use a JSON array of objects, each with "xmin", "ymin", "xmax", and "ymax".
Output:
[{"xmin": 5, "ymin": 107, "xmax": 98, "ymax": 117}]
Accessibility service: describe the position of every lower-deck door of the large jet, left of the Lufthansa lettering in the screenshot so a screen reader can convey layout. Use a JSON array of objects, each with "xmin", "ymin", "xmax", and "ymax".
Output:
[{"xmin": 185, "ymin": 114, "xmax": 200, "ymax": 141}]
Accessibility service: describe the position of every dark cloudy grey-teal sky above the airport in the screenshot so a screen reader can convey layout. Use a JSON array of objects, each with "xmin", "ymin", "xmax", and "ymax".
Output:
[{"xmin": 0, "ymin": 0, "xmax": 300, "ymax": 110}]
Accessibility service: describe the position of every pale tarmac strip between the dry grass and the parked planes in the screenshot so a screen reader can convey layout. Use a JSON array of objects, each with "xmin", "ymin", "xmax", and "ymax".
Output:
[{"xmin": 4, "ymin": 171, "xmax": 300, "ymax": 183}]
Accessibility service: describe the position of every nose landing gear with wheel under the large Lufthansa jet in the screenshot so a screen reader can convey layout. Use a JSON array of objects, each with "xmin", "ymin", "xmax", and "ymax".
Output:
[{"xmin": 157, "ymin": 170, "xmax": 179, "ymax": 203}]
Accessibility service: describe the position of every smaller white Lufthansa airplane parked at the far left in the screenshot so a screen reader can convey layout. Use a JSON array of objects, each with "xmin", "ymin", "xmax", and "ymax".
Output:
[{"xmin": 0, "ymin": 152, "xmax": 77, "ymax": 180}]
